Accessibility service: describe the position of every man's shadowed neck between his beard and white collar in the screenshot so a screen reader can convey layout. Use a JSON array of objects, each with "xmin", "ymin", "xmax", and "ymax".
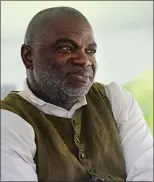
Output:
[{"xmin": 27, "ymin": 79, "xmax": 84, "ymax": 110}]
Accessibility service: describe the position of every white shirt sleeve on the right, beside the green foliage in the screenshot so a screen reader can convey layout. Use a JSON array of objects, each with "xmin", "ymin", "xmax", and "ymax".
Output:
[{"xmin": 105, "ymin": 82, "xmax": 153, "ymax": 181}]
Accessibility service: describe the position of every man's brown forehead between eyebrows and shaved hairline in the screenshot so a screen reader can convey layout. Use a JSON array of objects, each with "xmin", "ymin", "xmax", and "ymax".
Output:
[{"xmin": 36, "ymin": 18, "xmax": 94, "ymax": 44}]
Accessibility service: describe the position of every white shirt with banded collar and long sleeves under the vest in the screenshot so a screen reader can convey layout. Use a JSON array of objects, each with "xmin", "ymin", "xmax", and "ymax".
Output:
[{"xmin": 1, "ymin": 82, "xmax": 153, "ymax": 181}]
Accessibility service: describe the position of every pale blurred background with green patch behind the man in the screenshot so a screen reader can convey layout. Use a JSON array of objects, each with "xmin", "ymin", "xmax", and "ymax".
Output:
[{"xmin": 1, "ymin": 1, "xmax": 153, "ymax": 132}]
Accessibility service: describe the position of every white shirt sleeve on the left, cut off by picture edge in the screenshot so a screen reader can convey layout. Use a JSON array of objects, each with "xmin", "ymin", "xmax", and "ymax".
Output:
[{"xmin": 1, "ymin": 109, "xmax": 38, "ymax": 181}]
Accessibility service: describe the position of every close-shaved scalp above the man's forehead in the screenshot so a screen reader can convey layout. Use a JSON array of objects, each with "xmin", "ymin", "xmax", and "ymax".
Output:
[{"xmin": 24, "ymin": 7, "xmax": 90, "ymax": 44}]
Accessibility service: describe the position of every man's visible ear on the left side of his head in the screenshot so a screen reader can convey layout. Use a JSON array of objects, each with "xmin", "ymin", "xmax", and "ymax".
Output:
[{"xmin": 21, "ymin": 44, "xmax": 33, "ymax": 70}]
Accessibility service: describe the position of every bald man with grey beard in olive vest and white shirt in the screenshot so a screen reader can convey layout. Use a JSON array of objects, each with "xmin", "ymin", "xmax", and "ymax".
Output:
[{"xmin": 1, "ymin": 7, "xmax": 153, "ymax": 182}]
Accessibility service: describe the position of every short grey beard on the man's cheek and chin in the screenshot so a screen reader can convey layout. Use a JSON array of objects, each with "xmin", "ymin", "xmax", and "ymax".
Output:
[{"xmin": 35, "ymin": 65, "xmax": 92, "ymax": 109}]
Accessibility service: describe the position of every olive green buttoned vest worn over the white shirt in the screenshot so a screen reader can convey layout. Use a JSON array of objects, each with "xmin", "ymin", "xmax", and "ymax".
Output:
[{"xmin": 1, "ymin": 83, "xmax": 126, "ymax": 182}]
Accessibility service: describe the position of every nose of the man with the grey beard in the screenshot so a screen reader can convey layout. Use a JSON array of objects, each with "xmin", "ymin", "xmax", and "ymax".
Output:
[{"xmin": 72, "ymin": 50, "xmax": 92, "ymax": 67}]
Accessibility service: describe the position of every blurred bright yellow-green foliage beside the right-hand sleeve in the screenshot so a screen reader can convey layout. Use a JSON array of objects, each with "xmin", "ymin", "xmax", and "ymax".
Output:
[{"xmin": 124, "ymin": 70, "xmax": 153, "ymax": 133}]
